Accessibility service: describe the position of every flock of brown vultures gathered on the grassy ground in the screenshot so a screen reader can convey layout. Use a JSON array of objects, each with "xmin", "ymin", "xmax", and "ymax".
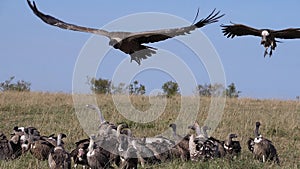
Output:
[{"xmin": 0, "ymin": 105, "xmax": 279, "ymax": 169}]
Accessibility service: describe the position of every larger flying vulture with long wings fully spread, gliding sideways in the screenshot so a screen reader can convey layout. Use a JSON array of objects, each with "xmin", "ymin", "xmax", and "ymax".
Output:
[{"xmin": 27, "ymin": 0, "xmax": 224, "ymax": 65}]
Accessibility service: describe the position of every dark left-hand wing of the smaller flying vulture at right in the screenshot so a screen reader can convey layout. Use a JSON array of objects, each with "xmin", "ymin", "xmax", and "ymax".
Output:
[{"xmin": 221, "ymin": 24, "xmax": 261, "ymax": 38}]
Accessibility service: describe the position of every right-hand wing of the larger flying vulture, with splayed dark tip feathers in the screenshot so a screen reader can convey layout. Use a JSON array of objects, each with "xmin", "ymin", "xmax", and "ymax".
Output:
[{"xmin": 124, "ymin": 9, "xmax": 225, "ymax": 43}]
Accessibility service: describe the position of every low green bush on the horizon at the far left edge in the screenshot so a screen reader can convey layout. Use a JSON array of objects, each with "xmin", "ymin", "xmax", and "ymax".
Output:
[{"xmin": 0, "ymin": 76, "xmax": 31, "ymax": 92}]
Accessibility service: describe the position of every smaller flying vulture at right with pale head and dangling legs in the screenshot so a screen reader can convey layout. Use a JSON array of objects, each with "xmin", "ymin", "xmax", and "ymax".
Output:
[{"xmin": 221, "ymin": 24, "xmax": 300, "ymax": 57}]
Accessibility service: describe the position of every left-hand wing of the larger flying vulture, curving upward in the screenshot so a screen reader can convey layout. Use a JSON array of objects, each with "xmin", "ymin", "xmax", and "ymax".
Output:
[{"xmin": 27, "ymin": 0, "xmax": 108, "ymax": 36}]
